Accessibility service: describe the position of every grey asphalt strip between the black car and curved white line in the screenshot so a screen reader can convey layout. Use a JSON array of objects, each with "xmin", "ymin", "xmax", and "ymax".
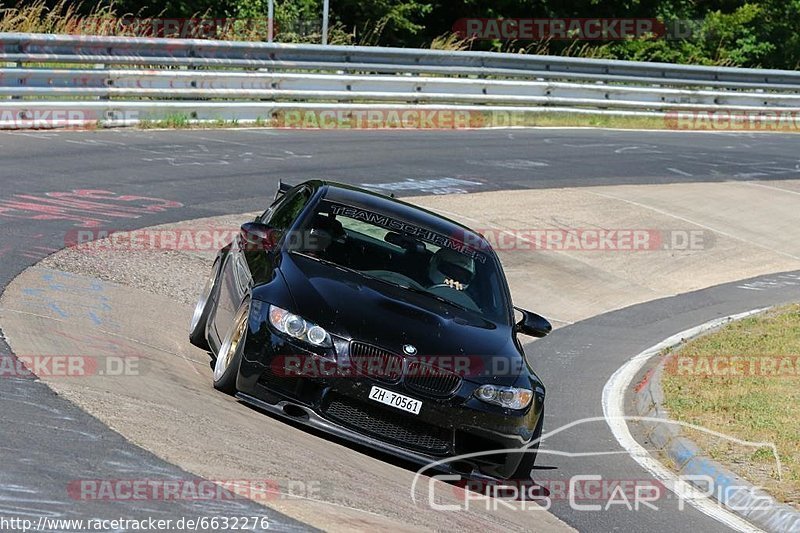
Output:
[{"xmin": 526, "ymin": 271, "xmax": 800, "ymax": 532}]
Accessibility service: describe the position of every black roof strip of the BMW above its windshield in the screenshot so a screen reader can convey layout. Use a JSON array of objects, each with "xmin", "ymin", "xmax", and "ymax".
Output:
[{"xmin": 314, "ymin": 181, "xmax": 492, "ymax": 251}]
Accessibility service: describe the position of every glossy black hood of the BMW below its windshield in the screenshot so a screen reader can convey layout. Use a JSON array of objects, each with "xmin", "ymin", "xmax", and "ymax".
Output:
[{"xmin": 280, "ymin": 253, "xmax": 524, "ymax": 385}]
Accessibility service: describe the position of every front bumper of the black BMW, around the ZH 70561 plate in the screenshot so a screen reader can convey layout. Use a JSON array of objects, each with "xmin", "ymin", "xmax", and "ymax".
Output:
[{"xmin": 237, "ymin": 325, "xmax": 544, "ymax": 478}]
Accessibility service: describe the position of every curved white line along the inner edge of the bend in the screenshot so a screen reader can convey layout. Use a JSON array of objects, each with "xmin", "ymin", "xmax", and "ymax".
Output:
[{"xmin": 603, "ymin": 308, "xmax": 765, "ymax": 532}]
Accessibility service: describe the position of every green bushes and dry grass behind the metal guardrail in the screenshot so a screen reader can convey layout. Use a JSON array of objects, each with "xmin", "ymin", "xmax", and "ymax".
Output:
[{"xmin": 0, "ymin": 0, "xmax": 800, "ymax": 69}]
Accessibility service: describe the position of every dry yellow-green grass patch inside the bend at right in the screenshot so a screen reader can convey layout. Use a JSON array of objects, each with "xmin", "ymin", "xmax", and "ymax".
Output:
[{"xmin": 663, "ymin": 304, "xmax": 800, "ymax": 507}]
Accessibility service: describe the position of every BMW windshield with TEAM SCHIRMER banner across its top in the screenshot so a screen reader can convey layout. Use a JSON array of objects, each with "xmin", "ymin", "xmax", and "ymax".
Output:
[{"xmin": 292, "ymin": 201, "xmax": 508, "ymax": 323}]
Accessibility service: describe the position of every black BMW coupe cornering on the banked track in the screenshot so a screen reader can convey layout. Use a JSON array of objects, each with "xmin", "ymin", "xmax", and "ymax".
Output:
[{"xmin": 190, "ymin": 181, "xmax": 551, "ymax": 479}]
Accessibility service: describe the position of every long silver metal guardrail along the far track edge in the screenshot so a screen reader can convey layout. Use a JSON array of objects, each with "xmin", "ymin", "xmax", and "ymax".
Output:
[{"xmin": 0, "ymin": 33, "xmax": 800, "ymax": 127}]
